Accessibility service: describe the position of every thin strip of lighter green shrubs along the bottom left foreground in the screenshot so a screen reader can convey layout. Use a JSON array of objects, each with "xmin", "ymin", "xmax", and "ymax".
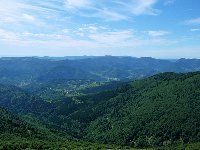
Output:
[{"xmin": 0, "ymin": 136, "xmax": 121, "ymax": 150}]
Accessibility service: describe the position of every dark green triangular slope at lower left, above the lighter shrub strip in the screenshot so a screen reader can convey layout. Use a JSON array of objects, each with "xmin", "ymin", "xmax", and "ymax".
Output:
[{"xmin": 0, "ymin": 108, "xmax": 59, "ymax": 140}]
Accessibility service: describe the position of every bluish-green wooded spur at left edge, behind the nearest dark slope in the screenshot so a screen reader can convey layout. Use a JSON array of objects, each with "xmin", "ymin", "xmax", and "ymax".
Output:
[{"xmin": 0, "ymin": 85, "xmax": 53, "ymax": 116}]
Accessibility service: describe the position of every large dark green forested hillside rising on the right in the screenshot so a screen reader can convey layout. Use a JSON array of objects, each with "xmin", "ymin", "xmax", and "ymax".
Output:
[{"xmin": 65, "ymin": 72, "xmax": 200, "ymax": 147}]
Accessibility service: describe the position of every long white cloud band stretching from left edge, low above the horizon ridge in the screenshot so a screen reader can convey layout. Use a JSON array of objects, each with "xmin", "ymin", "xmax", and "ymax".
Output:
[{"xmin": 0, "ymin": 25, "xmax": 174, "ymax": 50}]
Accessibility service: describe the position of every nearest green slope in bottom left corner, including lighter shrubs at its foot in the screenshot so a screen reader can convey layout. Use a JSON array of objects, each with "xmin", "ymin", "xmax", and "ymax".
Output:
[{"xmin": 0, "ymin": 107, "xmax": 120, "ymax": 150}]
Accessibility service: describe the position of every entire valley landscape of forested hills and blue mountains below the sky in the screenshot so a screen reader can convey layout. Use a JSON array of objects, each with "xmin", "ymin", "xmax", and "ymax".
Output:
[{"xmin": 0, "ymin": 56, "xmax": 200, "ymax": 149}]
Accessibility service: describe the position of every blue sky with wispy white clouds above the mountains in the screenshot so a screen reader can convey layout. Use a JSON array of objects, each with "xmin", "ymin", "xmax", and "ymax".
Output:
[{"xmin": 0, "ymin": 0, "xmax": 200, "ymax": 59}]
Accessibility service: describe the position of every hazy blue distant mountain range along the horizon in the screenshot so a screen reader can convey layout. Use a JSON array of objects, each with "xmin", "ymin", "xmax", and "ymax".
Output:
[{"xmin": 0, "ymin": 56, "xmax": 200, "ymax": 87}]
